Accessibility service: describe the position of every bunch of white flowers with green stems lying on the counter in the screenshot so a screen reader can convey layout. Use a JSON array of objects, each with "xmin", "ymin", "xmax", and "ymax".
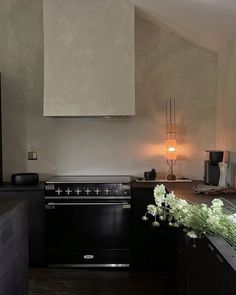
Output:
[{"xmin": 143, "ymin": 184, "xmax": 236, "ymax": 249}]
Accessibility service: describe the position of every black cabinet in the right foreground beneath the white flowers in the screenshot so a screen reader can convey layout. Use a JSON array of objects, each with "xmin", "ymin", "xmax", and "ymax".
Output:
[{"xmin": 177, "ymin": 232, "xmax": 236, "ymax": 295}]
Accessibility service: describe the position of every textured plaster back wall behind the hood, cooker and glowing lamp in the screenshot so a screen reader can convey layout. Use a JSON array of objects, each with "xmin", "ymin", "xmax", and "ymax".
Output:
[{"xmin": 0, "ymin": 0, "xmax": 216, "ymax": 179}]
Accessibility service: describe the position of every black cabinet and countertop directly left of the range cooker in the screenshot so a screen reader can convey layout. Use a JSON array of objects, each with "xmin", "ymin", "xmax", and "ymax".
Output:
[{"xmin": 0, "ymin": 183, "xmax": 45, "ymax": 266}]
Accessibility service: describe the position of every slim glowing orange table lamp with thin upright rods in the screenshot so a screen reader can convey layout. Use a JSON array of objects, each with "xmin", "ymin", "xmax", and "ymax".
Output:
[{"xmin": 166, "ymin": 99, "xmax": 177, "ymax": 180}]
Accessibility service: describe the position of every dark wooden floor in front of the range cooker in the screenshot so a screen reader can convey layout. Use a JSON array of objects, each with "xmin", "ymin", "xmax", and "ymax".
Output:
[{"xmin": 29, "ymin": 268, "xmax": 177, "ymax": 295}]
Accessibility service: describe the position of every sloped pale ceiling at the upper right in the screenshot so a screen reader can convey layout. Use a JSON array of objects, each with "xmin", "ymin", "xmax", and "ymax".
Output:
[{"xmin": 134, "ymin": 0, "xmax": 236, "ymax": 52}]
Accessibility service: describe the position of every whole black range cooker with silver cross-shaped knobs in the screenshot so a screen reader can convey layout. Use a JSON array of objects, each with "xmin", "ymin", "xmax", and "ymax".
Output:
[{"xmin": 45, "ymin": 176, "xmax": 131, "ymax": 267}]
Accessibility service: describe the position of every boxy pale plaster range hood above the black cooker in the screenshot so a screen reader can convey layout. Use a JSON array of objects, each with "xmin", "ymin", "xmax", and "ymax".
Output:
[{"xmin": 43, "ymin": 0, "xmax": 135, "ymax": 116}]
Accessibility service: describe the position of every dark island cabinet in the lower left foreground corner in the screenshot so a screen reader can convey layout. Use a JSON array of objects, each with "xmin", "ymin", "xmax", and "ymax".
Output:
[{"xmin": 0, "ymin": 198, "xmax": 29, "ymax": 295}]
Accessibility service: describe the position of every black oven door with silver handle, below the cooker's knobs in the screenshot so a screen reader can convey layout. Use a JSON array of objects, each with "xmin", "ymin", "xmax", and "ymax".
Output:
[{"xmin": 45, "ymin": 199, "xmax": 131, "ymax": 266}]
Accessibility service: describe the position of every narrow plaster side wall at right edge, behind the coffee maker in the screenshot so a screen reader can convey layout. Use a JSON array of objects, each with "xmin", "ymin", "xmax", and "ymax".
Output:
[{"xmin": 216, "ymin": 42, "xmax": 236, "ymax": 186}]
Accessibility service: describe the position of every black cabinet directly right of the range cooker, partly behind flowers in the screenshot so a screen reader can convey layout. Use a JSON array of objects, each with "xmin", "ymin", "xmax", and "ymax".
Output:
[{"xmin": 132, "ymin": 185, "xmax": 177, "ymax": 269}]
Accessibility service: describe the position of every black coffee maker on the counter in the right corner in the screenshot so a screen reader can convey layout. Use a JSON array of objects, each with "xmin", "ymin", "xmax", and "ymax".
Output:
[{"xmin": 204, "ymin": 150, "xmax": 224, "ymax": 185}]
